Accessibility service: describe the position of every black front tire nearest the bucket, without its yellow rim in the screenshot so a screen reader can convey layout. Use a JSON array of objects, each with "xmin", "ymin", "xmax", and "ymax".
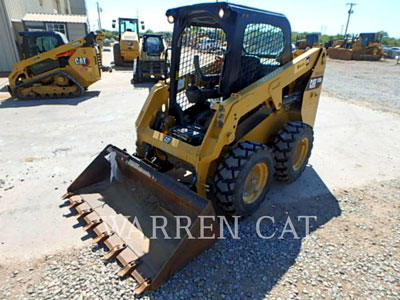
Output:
[{"xmin": 213, "ymin": 141, "xmax": 274, "ymax": 217}]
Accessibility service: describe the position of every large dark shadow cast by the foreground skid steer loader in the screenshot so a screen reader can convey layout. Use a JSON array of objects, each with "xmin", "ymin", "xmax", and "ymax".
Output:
[{"xmin": 141, "ymin": 167, "xmax": 341, "ymax": 299}]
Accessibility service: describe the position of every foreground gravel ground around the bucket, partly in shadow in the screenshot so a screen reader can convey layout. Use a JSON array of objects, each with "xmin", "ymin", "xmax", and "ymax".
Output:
[{"xmin": 0, "ymin": 180, "xmax": 400, "ymax": 300}]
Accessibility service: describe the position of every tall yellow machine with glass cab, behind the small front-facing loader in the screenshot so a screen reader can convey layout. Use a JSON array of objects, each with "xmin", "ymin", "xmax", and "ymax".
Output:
[{"xmin": 112, "ymin": 18, "xmax": 144, "ymax": 66}]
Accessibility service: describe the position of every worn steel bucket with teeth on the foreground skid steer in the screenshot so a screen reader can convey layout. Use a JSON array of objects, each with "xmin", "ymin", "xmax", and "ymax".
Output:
[{"xmin": 63, "ymin": 145, "xmax": 219, "ymax": 294}]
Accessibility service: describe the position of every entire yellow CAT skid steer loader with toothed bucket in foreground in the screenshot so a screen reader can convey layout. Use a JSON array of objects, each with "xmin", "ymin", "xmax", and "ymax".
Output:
[{"xmin": 63, "ymin": 2, "xmax": 326, "ymax": 294}]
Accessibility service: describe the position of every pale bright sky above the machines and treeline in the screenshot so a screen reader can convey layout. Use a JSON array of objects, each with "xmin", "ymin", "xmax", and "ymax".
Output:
[{"xmin": 86, "ymin": 0, "xmax": 400, "ymax": 38}]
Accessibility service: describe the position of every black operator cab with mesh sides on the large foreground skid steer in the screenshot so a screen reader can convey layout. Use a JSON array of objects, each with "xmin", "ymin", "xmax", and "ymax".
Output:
[{"xmin": 166, "ymin": 2, "xmax": 292, "ymax": 144}]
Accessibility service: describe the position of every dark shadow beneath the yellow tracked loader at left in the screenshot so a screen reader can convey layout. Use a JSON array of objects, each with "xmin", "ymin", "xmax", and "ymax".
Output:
[{"xmin": 0, "ymin": 91, "xmax": 100, "ymax": 108}]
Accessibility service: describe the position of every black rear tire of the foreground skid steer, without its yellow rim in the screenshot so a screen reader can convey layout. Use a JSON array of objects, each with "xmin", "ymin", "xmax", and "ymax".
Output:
[{"xmin": 273, "ymin": 122, "xmax": 314, "ymax": 183}]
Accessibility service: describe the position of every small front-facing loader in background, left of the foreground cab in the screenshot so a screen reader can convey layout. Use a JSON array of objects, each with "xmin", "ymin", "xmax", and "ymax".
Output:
[{"xmin": 131, "ymin": 34, "xmax": 168, "ymax": 84}]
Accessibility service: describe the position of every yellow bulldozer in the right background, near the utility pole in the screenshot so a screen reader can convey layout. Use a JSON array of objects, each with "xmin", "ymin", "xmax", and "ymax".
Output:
[{"xmin": 328, "ymin": 33, "xmax": 384, "ymax": 61}]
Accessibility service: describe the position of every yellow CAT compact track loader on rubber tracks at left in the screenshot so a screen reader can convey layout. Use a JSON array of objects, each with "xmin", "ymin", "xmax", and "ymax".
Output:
[{"xmin": 8, "ymin": 31, "xmax": 108, "ymax": 100}]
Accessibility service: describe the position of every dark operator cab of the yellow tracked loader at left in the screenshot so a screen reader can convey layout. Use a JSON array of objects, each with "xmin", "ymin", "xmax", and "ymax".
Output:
[{"xmin": 19, "ymin": 31, "xmax": 68, "ymax": 59}]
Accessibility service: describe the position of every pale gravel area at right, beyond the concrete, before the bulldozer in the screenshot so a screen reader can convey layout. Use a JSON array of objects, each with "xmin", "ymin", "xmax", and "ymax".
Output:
[{"xmin": 323, "ymin": 59, "xmax": 400, "ymax": 114}]
